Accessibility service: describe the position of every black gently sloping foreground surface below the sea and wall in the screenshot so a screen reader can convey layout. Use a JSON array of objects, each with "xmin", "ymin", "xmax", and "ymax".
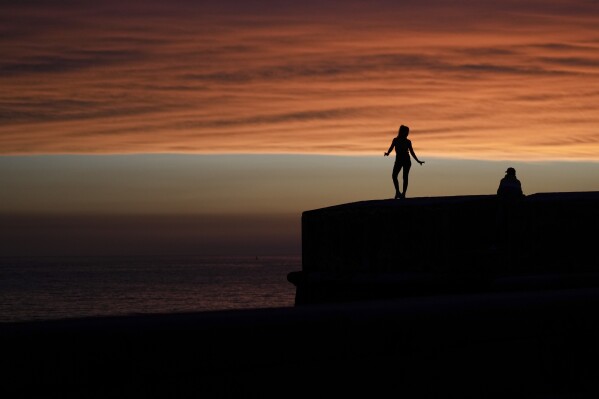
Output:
[{"xmin": 0, "ymin": 288, "xmax": 599, "ymax": 398}]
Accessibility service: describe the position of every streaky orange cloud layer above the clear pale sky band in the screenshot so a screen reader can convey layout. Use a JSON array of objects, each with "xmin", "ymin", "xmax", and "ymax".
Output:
[{"xmin": 0, "ymin": 0, "xmax": 599, "ymax": 161}]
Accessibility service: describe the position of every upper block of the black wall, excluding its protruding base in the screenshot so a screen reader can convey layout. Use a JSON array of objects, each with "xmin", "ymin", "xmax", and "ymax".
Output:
[{"xmin": 302, "ymin": 192, "xmax": 599, "ymax": 273}]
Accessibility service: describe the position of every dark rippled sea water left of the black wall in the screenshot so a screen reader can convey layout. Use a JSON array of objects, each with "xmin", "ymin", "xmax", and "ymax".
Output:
[{"xmin": 0, "ymin": 256, "xmax": 301, "ymax": 322}]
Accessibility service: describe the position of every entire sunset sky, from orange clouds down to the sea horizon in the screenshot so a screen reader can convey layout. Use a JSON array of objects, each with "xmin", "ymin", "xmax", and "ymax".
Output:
[{"xmin": 0, "ymin": 0, "xmax": 599, "ymax": 255}]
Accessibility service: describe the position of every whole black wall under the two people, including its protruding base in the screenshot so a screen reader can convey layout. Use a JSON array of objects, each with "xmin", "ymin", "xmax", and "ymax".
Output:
[{"xmin": 288, "ymin": 192, "xmax": 599, "ymax": 305}]
